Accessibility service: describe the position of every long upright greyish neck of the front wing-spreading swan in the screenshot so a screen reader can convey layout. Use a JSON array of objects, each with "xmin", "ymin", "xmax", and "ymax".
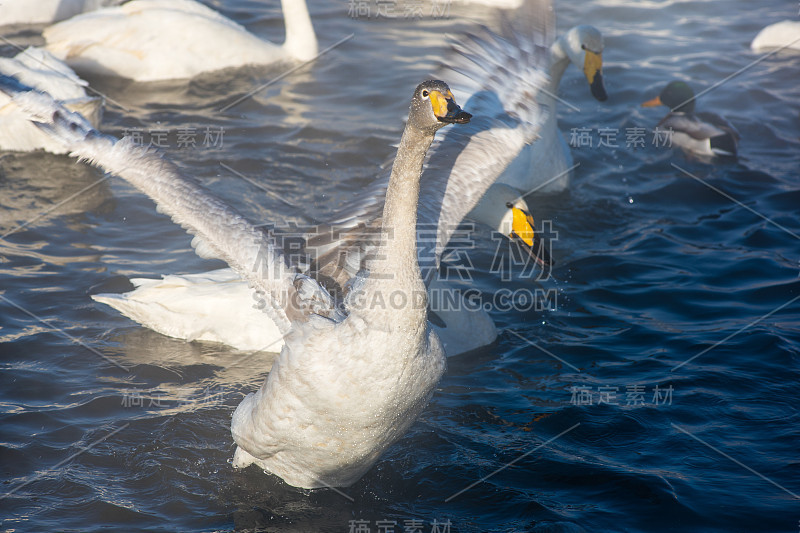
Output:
[{"xmin": 370, "ymin": 122, "xmax": 433, "ymax": 289}]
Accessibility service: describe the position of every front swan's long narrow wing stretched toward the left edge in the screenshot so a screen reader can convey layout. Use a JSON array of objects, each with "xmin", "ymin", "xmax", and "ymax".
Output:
[{"xmin": 0, "ymin": 76, "xmax": 333, "ymax": 334}]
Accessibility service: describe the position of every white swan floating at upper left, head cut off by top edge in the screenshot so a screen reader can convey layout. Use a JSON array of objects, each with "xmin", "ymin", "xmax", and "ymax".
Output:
[{"xmin": 44, "ymin": 0, "xmax": 317, "ymax": 81}]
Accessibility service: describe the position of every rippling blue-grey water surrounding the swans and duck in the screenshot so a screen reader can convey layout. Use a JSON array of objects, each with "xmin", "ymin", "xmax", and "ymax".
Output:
[{"xmin": 0, "ymin": 0, "xmax": 800, "ymax": 532}]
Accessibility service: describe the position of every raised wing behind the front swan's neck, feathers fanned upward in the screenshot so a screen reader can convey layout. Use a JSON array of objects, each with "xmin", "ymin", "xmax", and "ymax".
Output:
[{"xmin": 304, "ymin": 0, "xmax": 555, "ymax": 281}]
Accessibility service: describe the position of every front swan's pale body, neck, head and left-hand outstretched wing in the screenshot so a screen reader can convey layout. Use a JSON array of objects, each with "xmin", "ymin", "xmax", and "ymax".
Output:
[{"xmin": 0, "ymin": 77, "xmax": 470, "ymax": 488}]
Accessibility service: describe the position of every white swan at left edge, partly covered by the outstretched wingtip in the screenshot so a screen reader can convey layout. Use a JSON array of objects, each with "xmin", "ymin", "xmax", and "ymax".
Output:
[{"xmin": 0, "ymin": 47, "xmax": 103, "ymax": 154}]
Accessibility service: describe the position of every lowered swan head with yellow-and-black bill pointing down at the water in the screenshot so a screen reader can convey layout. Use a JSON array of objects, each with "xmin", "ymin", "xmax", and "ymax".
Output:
[{"xmin": 470, "ymin": 183, "xmax": 554, "ymax": 267}]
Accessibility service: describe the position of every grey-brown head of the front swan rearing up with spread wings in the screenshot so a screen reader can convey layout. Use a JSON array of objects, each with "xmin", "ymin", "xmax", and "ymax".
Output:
[{"xmin": 408, "ymin": 80, "xmax": 472, "ymax": 133}]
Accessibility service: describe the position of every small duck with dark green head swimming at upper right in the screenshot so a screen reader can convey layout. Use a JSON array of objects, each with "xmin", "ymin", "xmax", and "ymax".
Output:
[{"xmin": 642, "ymin": 81, "xmax": 739, "ymax": 160}]
